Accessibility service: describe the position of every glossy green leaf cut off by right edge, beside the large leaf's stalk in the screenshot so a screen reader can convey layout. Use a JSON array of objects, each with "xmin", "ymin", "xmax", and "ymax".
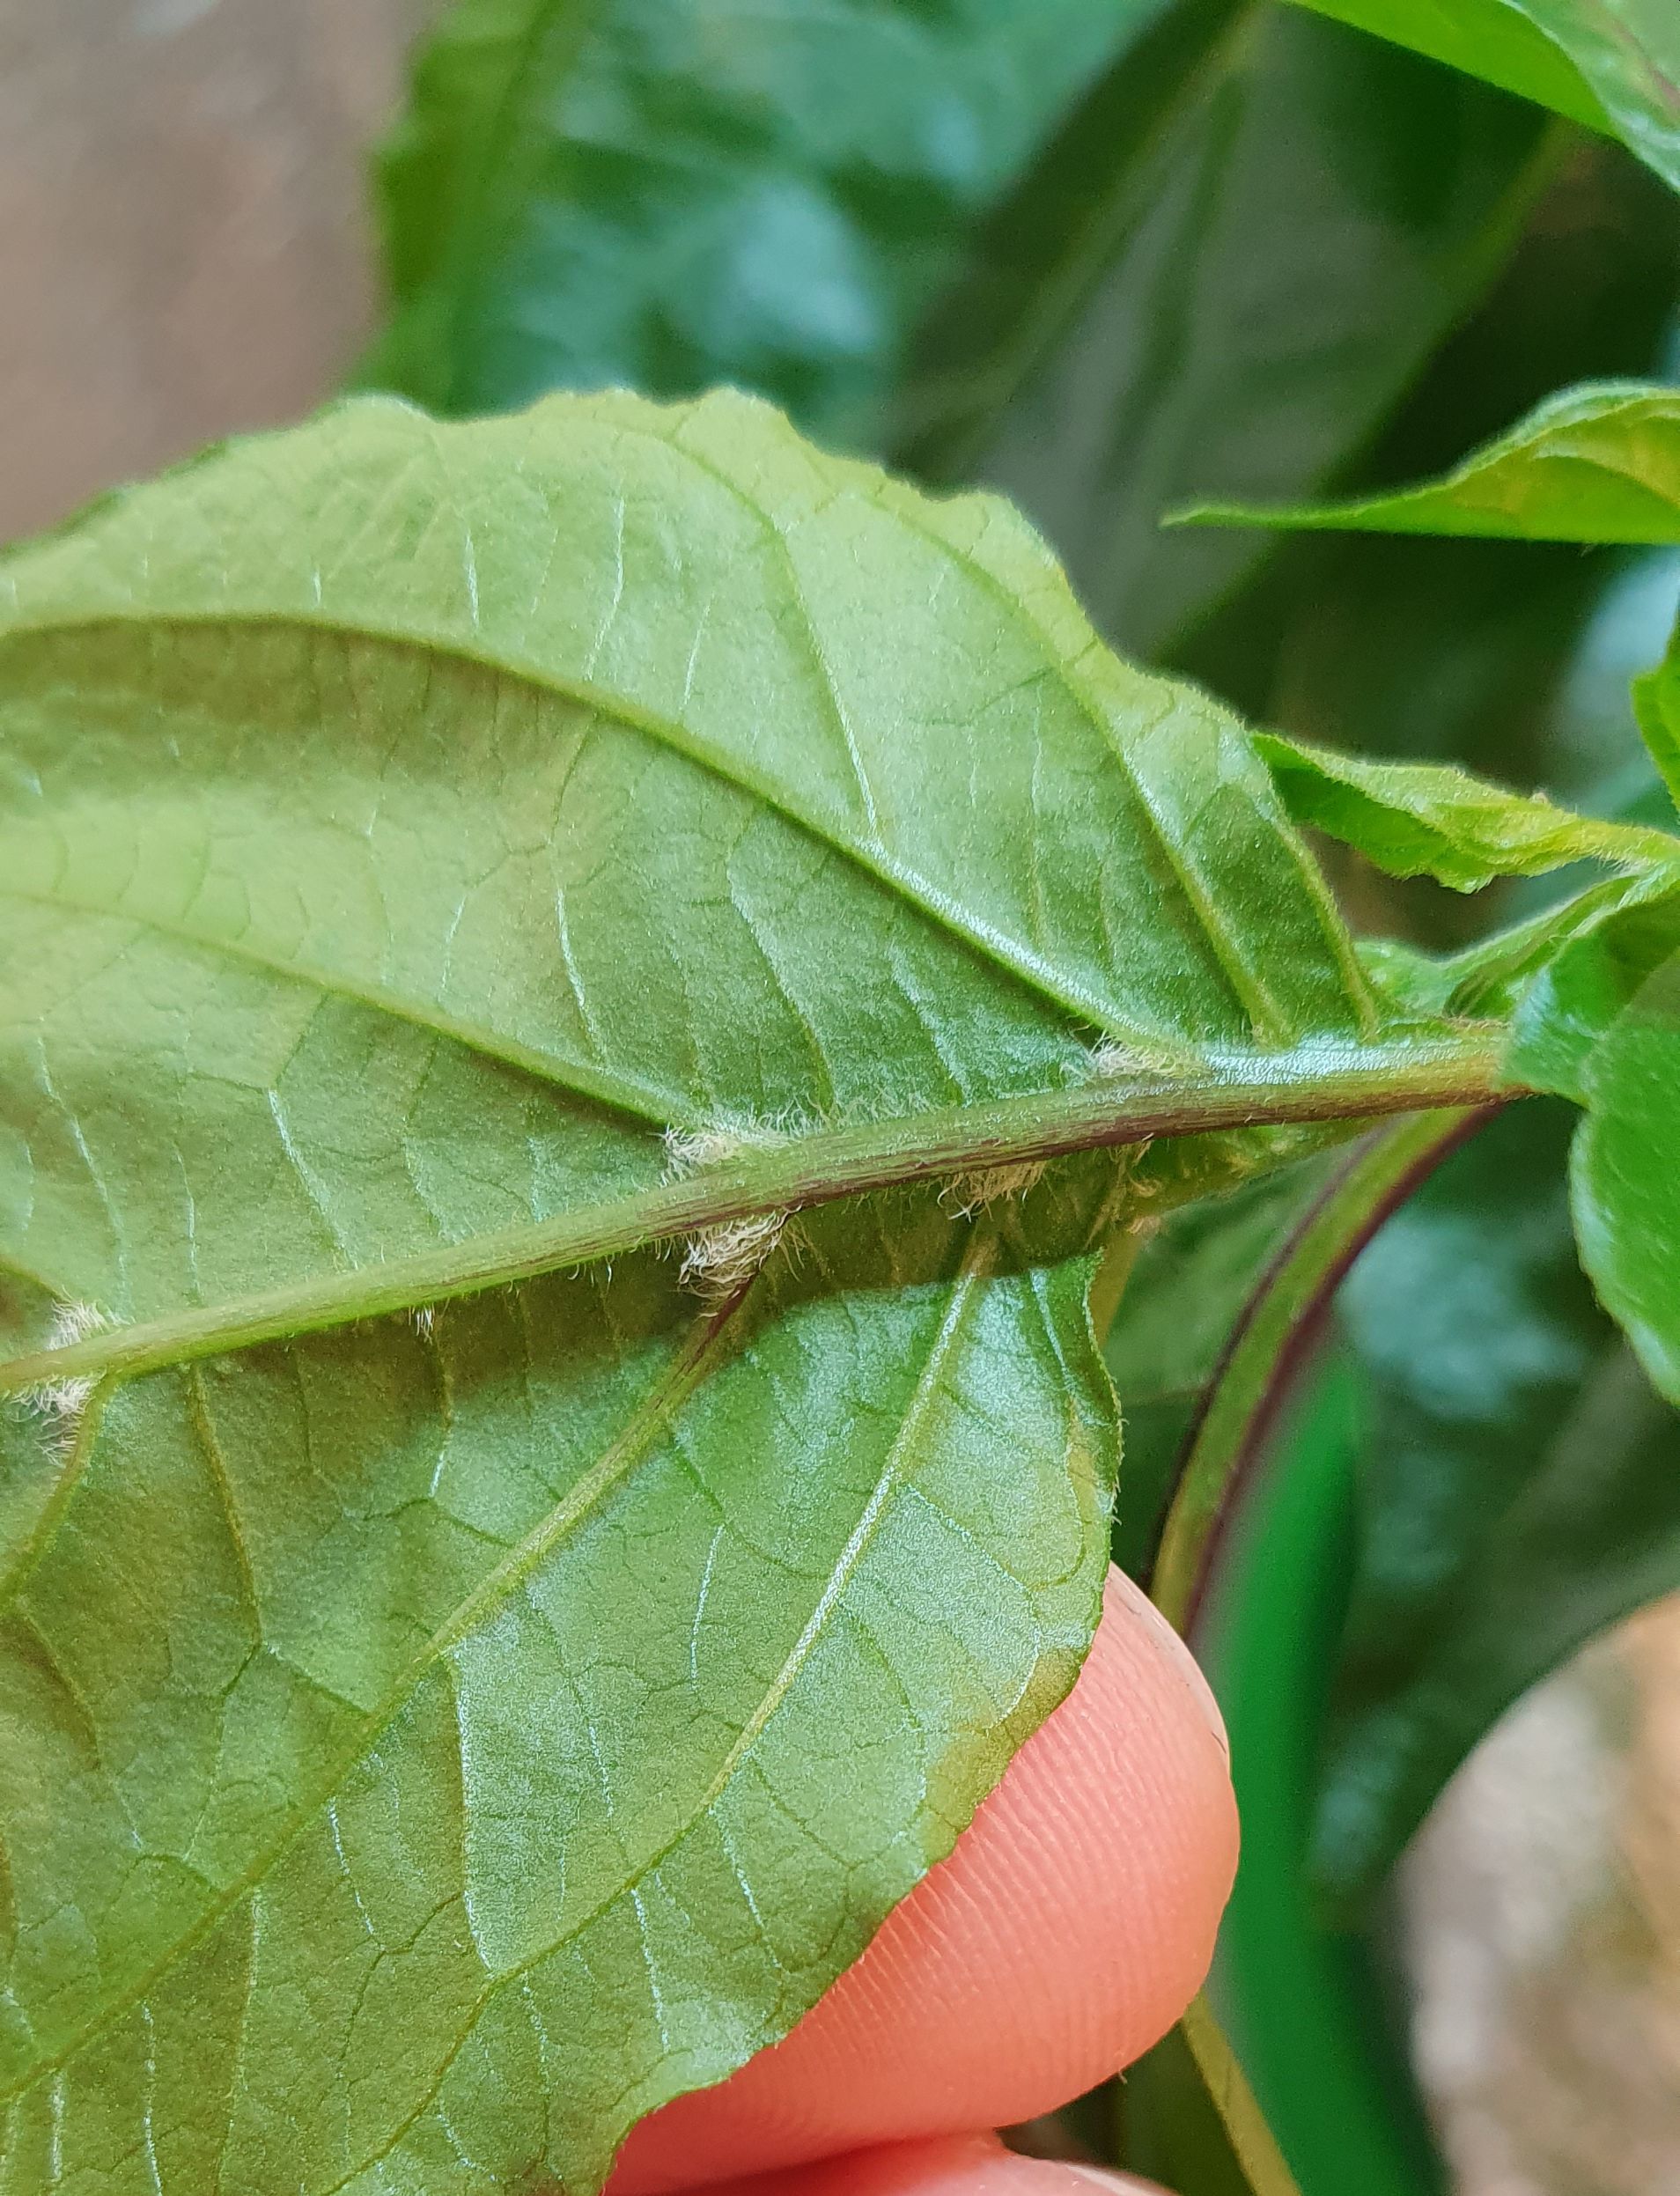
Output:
[{"xmin": 1570, "ymin": 955, "xmax": 1680, "ymax": 1401}]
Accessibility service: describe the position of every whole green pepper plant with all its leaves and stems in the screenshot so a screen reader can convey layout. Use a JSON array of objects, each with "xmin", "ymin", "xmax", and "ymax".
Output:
[{"xmin": 0, "ymin": 0, "xmax": 1680, "ymax": 2196}]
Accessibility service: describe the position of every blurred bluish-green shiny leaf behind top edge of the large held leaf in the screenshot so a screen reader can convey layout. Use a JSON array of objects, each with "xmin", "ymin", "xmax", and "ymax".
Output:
[{"xmin": 365, "ymin": 0, "xmax": 1161, "ymax": 441}]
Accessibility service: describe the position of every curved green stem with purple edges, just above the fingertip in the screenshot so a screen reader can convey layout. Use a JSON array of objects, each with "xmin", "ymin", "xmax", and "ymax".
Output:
[{"xmin": 1151, "ymin": 1104, "xmax": 1492, "ymax": 1632}]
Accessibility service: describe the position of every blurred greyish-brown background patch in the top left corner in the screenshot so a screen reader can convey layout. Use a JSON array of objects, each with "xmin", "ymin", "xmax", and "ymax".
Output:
[{"xmin": 0, "ymin": 0, "xmax": 426, "ymax": 538}]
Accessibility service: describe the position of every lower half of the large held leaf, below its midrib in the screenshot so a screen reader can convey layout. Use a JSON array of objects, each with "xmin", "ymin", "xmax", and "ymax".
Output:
[{"xmin": 0, "ymin": 1204, "xmax": 1114, "ymax": 2190}]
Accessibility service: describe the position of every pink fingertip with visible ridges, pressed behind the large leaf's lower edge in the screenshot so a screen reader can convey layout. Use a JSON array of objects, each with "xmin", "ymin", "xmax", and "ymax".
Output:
[{"xmin": 608, "ymin": 1573, "xmax": 1236, "ymax": 2196}]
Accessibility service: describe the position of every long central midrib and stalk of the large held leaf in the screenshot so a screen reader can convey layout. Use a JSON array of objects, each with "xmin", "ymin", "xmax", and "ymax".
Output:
[{"xmin": 0, "ymin": 1028, "xmax": 1498, "ymax": 1395}]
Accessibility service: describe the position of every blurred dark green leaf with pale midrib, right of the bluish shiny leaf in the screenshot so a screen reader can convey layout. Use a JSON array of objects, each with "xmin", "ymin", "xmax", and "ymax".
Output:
[{"xmin": 935, "ymin": 9, "xmax": 1557, "ymax": 654}]
